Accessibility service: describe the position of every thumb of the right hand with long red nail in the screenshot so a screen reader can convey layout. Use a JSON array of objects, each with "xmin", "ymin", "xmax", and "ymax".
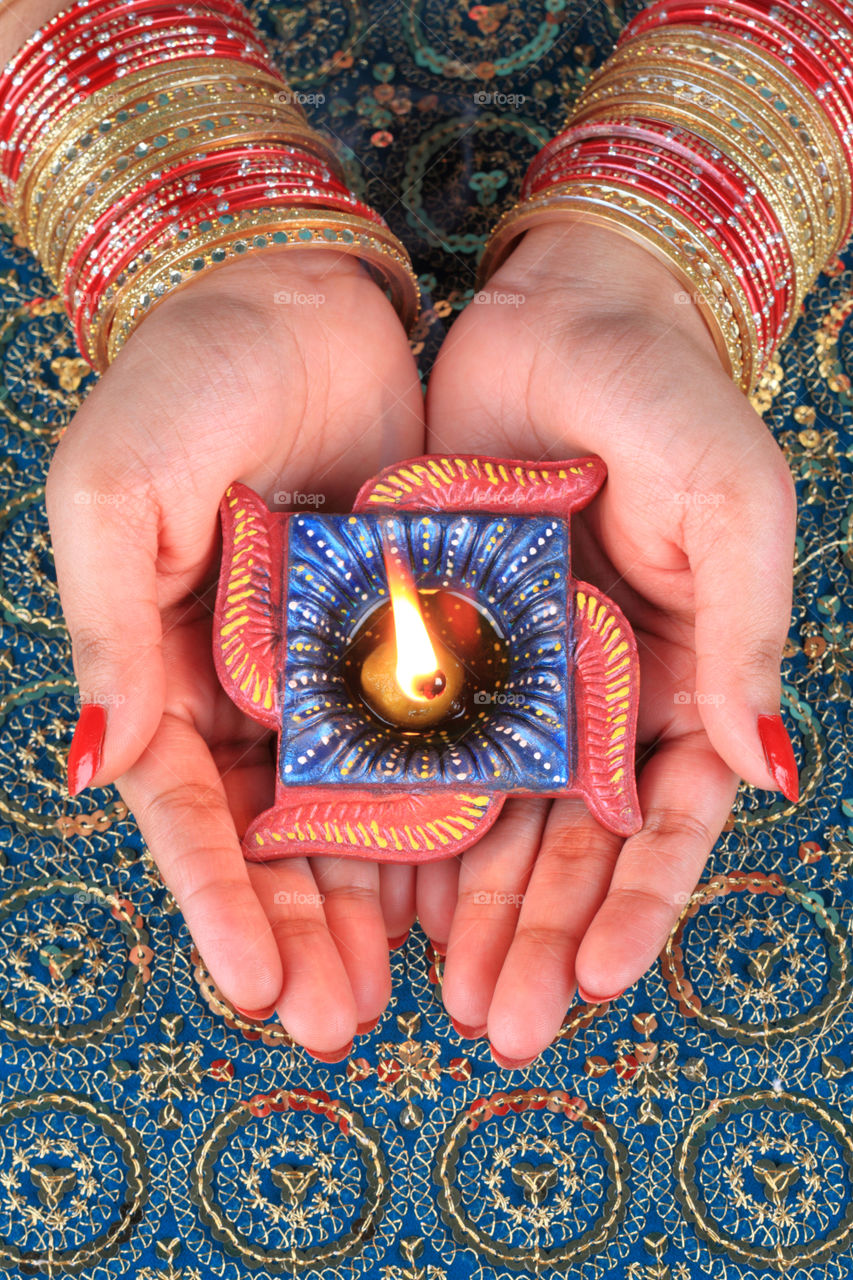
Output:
[{"xmin": 685, "ymin": 440, "xmax": 799, "ymax": 803}]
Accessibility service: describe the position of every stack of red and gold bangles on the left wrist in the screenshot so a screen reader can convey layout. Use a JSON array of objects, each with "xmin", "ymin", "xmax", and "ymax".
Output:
[{"xmin": 0, "ymin": 0, "xmax": 418, "ymax": 371}]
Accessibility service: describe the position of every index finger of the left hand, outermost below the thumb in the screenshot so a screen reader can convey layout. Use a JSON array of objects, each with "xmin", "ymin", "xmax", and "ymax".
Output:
[{"xmin": 119, "ymin": 714, "xmax": 282, "ymax": 1010}]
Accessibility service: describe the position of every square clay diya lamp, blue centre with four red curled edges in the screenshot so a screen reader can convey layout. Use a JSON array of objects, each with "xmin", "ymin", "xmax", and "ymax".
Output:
[{"xmin": 214, "ymin": 456, "xmax": 642, "ymax": 861}]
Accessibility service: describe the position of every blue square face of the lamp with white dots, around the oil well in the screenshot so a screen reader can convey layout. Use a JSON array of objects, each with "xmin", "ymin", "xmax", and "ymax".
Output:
[{"xmin": 279, "ymin": 512, "xmax": 573, "ymax": 794}]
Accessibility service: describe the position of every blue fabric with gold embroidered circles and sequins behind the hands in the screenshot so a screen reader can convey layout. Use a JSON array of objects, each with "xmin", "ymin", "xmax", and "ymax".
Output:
[{"xmin": 0, "ymin": 0, "xmax": 853, "ymax": 1280}]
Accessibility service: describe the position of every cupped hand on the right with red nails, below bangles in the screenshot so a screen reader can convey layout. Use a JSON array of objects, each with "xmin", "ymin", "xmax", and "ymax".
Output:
[{"xmin": 418, "ymin": 220, "xmax": 797, "ymax": 1065}]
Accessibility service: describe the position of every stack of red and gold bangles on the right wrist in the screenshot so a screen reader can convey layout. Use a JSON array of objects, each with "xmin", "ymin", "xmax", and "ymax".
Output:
[{"xmin": 480, "ymin": 0, "xmax": 853, "ymax": 392}]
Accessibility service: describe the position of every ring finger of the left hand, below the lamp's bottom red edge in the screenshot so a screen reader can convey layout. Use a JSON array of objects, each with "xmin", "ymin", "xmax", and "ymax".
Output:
[{"xmin": 311, "ymin": 858, "xmax": 391, "ymax": 1033}]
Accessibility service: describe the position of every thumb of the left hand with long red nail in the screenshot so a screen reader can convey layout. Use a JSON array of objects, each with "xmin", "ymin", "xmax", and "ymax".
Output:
[{"xmin": 45, "ymin": 419, "xmax": 165, "ymax": 795}]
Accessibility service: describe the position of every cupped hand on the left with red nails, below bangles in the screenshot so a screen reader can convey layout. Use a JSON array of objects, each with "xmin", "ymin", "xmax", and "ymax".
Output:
[{"xmin": 47, "ymin": 250, "xmax": 423, "ymax": 1053}]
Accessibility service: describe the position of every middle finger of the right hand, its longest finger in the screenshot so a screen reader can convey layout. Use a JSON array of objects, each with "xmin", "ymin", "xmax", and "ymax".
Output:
[{"xmin": 484, "ymin": 800, "xmax": 622, "ymax": 1068}]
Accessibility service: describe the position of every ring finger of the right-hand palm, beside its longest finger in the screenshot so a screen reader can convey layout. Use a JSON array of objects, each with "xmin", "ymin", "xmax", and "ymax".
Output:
[{"xmin": 442, "ymin": 800, "xmax": 548, "ymax": 1036}]
